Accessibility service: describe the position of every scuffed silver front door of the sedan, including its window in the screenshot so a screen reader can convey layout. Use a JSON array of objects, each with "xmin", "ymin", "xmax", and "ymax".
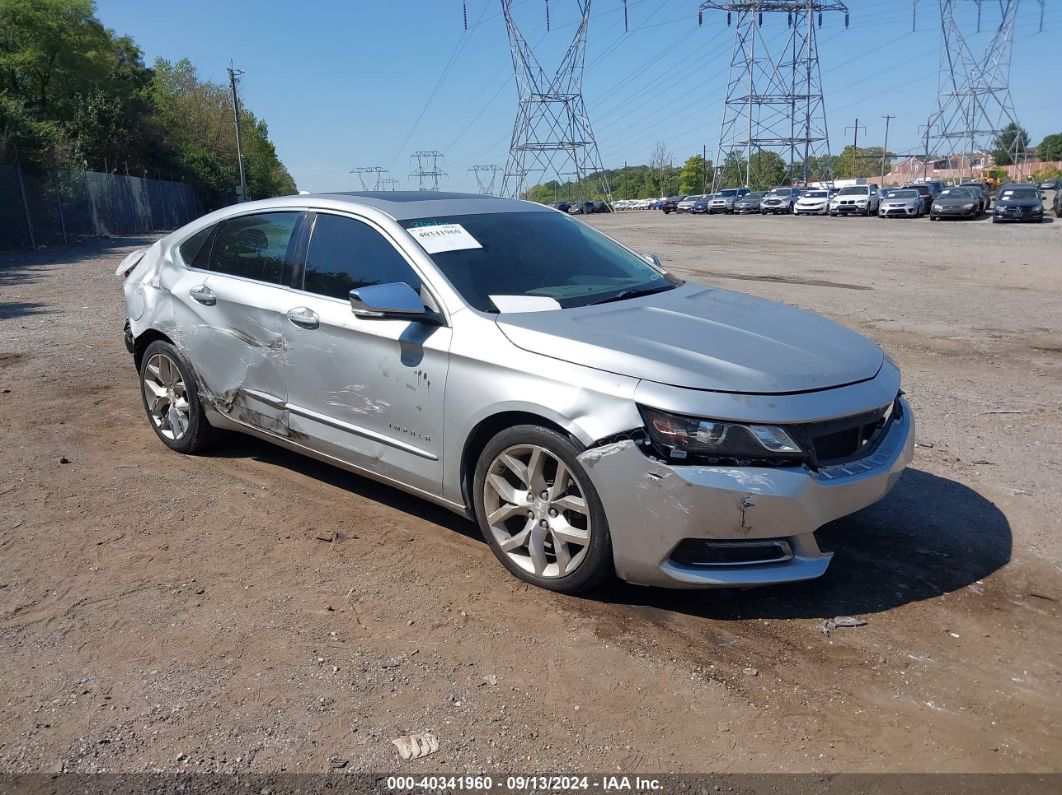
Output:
[{"xmin": 282, "ymin": 212, "xmax": 451, "ymax": 494}]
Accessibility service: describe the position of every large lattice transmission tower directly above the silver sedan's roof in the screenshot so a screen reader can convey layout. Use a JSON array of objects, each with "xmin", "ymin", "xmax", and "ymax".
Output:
[{"xmin": 501, "ymin": 0, "xmax": 627, "ymax": 202}]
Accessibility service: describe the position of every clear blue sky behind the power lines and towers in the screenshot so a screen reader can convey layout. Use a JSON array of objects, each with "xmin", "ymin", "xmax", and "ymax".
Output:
[{"xmin": 97, "ymin": 0, "xmax": 1062, "ymax": 191}]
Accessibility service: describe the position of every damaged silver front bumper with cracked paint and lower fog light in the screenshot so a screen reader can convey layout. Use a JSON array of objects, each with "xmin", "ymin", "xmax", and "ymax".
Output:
[{"xmin": 579, "ymin": 397, "xmax": 914, "ymax": 588}]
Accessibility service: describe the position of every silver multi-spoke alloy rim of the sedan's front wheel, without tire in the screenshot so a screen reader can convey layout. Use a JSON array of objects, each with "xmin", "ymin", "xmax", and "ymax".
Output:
[{"xmin": 483, "ymin": 445, "xmax": 590, "ymax": 578}]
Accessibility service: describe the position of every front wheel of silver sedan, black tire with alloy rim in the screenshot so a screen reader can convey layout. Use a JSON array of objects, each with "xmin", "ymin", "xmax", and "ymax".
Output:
[{"xmin": 473, "ymin": 425, "xmax": 615, "ymax": 593}]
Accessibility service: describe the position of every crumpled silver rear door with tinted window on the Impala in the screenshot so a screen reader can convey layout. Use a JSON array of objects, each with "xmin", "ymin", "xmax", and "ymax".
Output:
[{"xmin": 190, "ymin": 211, "xmax": 305, "ymax": 436}]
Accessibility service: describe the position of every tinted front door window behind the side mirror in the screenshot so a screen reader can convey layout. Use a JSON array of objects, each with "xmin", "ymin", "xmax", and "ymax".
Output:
[{"xmin": 304, "ymin": 213, "xmax": 421, "ymax": 300}]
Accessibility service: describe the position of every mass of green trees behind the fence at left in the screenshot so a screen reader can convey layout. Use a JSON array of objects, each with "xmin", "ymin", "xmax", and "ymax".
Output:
[{"xmin": 0, "ymin": 0, "xmax": 295, "ymax": 208}]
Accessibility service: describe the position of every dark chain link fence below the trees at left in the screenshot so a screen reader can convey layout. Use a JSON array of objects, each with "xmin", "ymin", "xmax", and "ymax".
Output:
[{"xmin": 0, "ymin": 166, "xmax": 203, "ymax": 250}]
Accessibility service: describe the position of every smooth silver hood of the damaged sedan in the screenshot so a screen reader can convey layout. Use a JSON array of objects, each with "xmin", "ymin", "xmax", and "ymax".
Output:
[{"xmin": 497, "ymin": 283, "xmax": 885, "ymax": 395}]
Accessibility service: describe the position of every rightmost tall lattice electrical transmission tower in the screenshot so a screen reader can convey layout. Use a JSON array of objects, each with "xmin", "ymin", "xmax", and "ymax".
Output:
[{"xmin": 931, "ymin": 0, "xmax": 1044, "ymax": 176}]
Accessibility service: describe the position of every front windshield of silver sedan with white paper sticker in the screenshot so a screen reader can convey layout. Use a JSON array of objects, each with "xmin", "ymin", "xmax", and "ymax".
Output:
[{"xmin": 401, "ymin": 211, "xmax": 682, "ymax": 312}]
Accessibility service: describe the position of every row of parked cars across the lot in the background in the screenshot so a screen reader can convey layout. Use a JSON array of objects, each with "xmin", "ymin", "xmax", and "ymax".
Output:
[{"xmin": 660, "ymin": 180, "xmax": 1062, "ymax": 223}]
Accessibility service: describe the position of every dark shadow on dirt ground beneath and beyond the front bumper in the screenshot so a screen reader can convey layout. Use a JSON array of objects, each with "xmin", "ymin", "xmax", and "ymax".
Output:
[{"xmin": 594, "ymin": 469, "xmax": 1012, "ymax": 620}]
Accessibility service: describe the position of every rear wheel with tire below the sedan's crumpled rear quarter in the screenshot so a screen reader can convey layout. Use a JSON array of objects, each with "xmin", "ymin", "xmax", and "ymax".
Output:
[{"xmin": 140, "ymin": 340, "xmax": 216, "ymax": 453}]
